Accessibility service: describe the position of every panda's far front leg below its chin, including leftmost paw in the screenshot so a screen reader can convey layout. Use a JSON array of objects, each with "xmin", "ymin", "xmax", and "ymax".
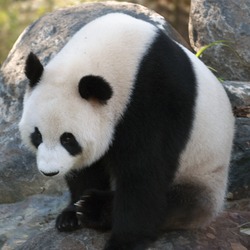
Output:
[{"xmin": 56, "ymin": 162, "xmax": 110, "ymax": 231}]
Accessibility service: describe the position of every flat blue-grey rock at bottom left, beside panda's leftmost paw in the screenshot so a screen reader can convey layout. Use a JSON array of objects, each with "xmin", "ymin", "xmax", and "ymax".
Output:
[{"xmin": 0, "ymin": 193, "xmax": 69, "ymax": 250}]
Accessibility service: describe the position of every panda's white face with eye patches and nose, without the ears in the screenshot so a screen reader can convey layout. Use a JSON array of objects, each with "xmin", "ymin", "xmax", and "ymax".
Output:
[{"xmin": 19, "ymin": 80, "xmax": 114, "ymax": 175}]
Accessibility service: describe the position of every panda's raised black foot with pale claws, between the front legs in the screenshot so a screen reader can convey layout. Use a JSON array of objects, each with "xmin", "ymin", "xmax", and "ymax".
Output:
[{"xmin": 75, "ymin": 190, "xmax": 113, "ymax": 230}]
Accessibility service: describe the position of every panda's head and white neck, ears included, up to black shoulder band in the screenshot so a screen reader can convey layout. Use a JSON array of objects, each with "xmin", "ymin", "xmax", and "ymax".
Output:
[{"xmin": 19, "ymin": 13, "xmax": 157, "ymax": 176}]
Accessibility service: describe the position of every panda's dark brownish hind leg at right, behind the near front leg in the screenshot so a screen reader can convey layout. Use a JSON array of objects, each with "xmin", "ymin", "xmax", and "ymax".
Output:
[{"xmin": 163, "ymin": 183, "xmax": 223, "ymax": 230}]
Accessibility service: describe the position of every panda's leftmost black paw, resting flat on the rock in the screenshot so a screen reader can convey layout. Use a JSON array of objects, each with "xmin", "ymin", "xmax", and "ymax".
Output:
[{"xmin": 56, "ymin": 207, "xmax": 81, "ymax": 232}]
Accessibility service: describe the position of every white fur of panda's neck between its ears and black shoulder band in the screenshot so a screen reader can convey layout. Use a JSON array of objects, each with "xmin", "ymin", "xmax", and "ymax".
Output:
[{"xmin": 44, "ymin": 12, "xmax": 158, "ymax": 124}]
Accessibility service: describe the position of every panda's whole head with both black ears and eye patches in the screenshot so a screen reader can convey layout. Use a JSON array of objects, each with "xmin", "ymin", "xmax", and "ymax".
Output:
[{"xmin": 19, "ymin": 53, "xmax": 113, "ymax": 176}]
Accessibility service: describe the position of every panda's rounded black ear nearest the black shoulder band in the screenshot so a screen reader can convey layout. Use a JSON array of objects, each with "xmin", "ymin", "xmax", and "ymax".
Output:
[{"xmin": 78, "ymin": 75, "xmax": 113, "ymax": 104}]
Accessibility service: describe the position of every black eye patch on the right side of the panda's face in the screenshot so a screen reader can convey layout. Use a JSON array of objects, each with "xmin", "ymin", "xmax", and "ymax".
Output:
[{"xmin": 60, "ymin": 132, "xmax": 82, "ymax": 156}]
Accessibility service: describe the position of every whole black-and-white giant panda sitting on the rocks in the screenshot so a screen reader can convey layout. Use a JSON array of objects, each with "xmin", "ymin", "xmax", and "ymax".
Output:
[{"xmin": 19, "ymin": 13, "xmax": 234, "ymax": 250}]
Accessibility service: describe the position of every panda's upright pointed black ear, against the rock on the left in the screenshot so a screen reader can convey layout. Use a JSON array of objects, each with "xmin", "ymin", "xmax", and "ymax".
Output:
[{"xmin": 24, "ymin": 52, "xmax": 44, "ymax": 88}]
